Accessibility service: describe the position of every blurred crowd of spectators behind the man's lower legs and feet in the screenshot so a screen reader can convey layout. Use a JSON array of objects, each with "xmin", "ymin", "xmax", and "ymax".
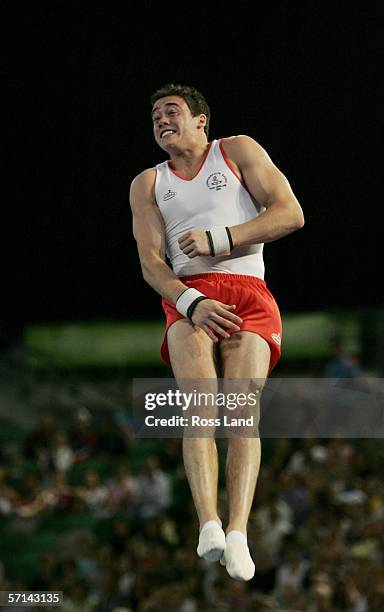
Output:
[{"xmin": 0, "ymin": 410, "xmax": 384, "ymax": 612}]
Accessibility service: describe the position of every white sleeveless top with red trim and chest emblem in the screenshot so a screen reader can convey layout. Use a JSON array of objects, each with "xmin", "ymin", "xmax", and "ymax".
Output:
[{"xmin": 155, "ymin": 140, "xmax": 265, "ymax": 278}]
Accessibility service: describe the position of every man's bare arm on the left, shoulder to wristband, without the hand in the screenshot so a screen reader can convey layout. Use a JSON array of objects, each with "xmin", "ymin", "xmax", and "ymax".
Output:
[{"xmin": 129, "ymin": 169, "xmax": 188, "ymax": 304}]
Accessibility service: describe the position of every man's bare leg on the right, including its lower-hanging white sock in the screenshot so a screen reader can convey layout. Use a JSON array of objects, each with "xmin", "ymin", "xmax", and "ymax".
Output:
[{"xmin": 220, "ymin": 331, "xmax": 270, "ymax": 580}]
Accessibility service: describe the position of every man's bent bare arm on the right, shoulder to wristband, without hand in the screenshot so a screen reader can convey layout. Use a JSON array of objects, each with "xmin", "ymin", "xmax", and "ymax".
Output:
[{"xmin": 224, "ymin": 136, "xmax": 304, "ymax": 247}]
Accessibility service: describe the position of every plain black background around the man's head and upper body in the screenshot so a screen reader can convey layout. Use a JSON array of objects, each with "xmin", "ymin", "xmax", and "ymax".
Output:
[{"xmin": 1, "ymin": 1, "xmax": 382, "ymax": 334}]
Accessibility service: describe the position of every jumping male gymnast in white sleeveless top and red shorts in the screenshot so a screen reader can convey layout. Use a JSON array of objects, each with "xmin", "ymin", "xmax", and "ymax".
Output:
[{"xmin": 130, "ymin": 85, "xmax": 304, "ymax": 580}]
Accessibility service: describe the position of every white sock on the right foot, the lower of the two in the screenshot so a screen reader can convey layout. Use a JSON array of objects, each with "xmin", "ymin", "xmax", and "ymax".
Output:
[{"xmin": 220, "ymin": 531, "xmax": 255, "ymax": 580}]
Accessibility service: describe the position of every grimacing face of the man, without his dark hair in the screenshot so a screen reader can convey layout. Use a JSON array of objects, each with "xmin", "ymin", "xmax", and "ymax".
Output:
[{"xmin": 152, "ymin": 96, "xmax": 206, "ymax": 152}]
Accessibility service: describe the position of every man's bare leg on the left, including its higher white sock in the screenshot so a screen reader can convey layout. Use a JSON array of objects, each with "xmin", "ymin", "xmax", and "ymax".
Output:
[{"xmin": 168, "ymin": 319, "xmax": 225, "ymax": 561}]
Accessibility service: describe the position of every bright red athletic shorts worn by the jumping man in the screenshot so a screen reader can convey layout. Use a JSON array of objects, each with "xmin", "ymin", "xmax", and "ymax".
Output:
[{"xmin": 161, "ymin": 272, "xmax": 282, "ymax": 372}]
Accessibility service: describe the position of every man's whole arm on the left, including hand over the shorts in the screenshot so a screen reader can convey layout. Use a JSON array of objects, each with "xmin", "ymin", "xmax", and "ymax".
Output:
[{"xmin": 129, "ymin": 168, "xmax": 242, "ymax": 342}]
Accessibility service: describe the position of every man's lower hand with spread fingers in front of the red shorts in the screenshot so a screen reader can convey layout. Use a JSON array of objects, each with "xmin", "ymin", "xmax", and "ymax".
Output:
[{"xmin": 192, "ymin": 299, "xmax": 243, "ymax": 342}]
